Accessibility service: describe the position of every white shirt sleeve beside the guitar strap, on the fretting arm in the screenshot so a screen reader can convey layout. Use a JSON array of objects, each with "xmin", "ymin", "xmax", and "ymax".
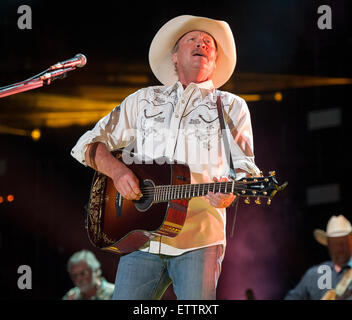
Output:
[{"xmin": 224, "ymin": 96, "xmax": 260, "ymax": 175}]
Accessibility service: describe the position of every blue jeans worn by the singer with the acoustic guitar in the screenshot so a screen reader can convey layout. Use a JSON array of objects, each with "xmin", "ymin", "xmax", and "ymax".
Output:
[{"xmin": 113, "ymin": 245, "xmax": 222, "ymax": 300}]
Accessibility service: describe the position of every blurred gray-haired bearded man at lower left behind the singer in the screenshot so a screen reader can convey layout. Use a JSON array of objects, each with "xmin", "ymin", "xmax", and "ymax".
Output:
[{"xmin": 63, "ymin": 250, "xmax": 114, "ymax": 300}]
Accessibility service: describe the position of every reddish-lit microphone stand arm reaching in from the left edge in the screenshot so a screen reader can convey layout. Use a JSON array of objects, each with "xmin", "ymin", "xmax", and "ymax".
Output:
[{"xmin": 0, "ymin": 67, "xmax": 76, "ymax": 98}]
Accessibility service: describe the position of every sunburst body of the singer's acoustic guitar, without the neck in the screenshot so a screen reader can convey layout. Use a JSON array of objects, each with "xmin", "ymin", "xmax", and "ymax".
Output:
[{"xmin": 86, "ymin": 150, "xmax": 191, "ymax": 254}]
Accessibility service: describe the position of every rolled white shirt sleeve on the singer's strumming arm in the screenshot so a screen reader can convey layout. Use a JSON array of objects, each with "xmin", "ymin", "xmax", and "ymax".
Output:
[{"xmin": 71, "ymin": 91, "xmax": 138, "ymax": 166}]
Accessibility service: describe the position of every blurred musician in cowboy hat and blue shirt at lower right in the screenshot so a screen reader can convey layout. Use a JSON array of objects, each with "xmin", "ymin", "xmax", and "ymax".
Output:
[{"xmin": 285, "ymin": 215, "xmax": 352, "ymax": 300}]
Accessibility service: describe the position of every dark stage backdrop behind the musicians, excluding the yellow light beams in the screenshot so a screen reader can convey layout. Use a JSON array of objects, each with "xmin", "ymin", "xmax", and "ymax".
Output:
[{"xmin": 0, "ymin": 0, "xmax": 352, "ymax": 300}]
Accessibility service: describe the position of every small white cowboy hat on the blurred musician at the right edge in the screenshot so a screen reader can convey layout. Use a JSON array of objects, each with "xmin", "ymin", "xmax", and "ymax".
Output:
[{"xmin": 313, "ymin": 215, "xmax": 352, "ymax": 246}]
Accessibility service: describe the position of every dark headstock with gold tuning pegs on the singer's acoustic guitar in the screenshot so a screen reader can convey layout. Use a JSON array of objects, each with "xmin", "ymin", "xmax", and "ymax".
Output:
[{"xmin": 234, "ymin": 171, "xmax": 288, "ymax": 205}]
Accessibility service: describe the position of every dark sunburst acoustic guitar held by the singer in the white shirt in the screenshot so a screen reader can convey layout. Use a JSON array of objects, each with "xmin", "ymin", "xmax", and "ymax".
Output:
[{"xmin": 86, "ymin": 150, "xmax": 287, "ymax": 254}]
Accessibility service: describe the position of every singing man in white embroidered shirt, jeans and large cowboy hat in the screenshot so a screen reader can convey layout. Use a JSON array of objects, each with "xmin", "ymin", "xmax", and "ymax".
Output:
[{"xmin": 71, "ymin": 15, "xmax": 260, "ymax": 299}]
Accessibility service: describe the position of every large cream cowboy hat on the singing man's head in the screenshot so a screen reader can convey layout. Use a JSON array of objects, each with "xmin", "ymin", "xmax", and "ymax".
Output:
[{"xmin": 149, "ymin": 15, "xmax": 236, "ymax": 88}]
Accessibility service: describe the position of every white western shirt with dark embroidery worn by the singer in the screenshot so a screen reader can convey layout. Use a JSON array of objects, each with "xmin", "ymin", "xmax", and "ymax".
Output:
[{"xmin": 71, "ymin": 81, "xmax": 260, "ymax": 255}]
